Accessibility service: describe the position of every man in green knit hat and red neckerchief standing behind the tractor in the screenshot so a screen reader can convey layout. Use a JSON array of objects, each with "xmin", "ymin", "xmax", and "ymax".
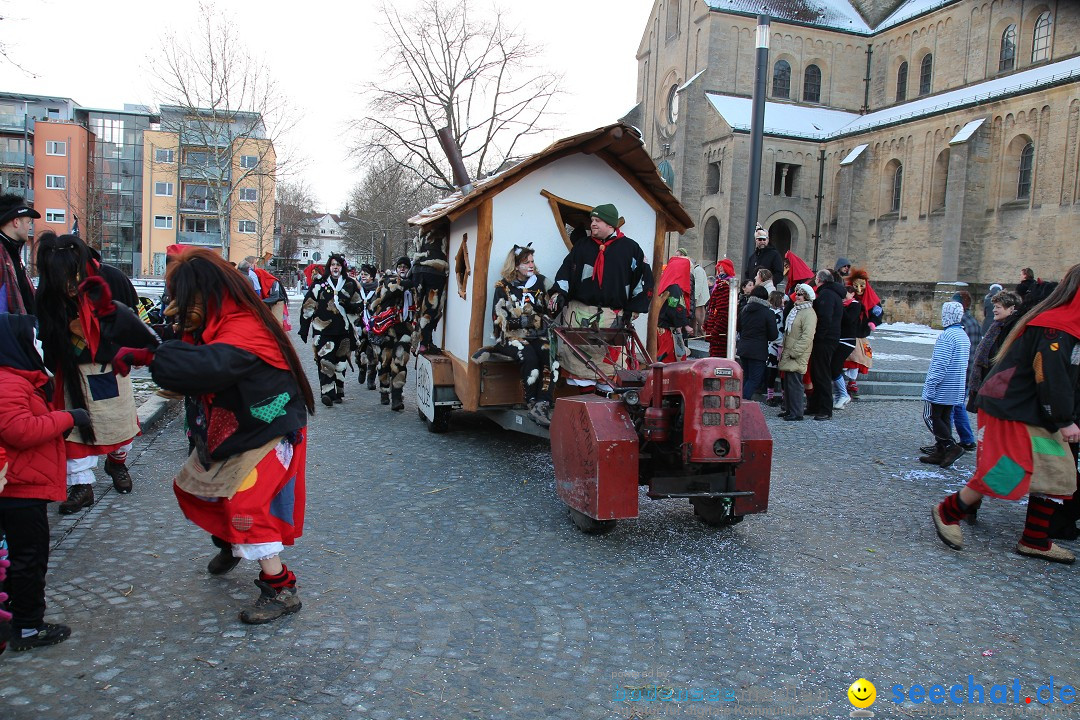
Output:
[{"xmin": 550, "ymin": 204, "xmax": 652, "ymax": 388}]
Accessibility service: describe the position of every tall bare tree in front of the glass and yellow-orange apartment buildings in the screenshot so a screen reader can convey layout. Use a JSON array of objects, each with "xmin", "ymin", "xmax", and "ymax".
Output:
[{"xmin": 150, "ymin": 3, "xmax": 296, "ymax": 258}]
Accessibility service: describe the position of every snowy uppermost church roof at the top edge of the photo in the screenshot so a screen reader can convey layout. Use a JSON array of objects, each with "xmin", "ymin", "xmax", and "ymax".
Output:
[{"xmin": 705, "ymin": 0, "xmax": 956, "ymax": 35}]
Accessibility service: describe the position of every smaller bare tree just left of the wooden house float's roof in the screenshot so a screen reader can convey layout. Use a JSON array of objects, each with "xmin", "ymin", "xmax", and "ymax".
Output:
[{"xmin": 345, "ymin": 155, "xmax": 437, "ymax": 268}]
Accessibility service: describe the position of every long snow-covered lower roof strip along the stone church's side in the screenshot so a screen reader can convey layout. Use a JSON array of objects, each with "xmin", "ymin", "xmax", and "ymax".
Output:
[{"xmin": 706, "ymin": 56, "xmax": 1080, "ymax": 140}]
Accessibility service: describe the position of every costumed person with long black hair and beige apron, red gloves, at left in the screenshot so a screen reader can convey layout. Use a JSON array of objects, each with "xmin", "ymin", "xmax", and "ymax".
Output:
[{"xmin": 35, "ymin": 232, "xmax": 150, "ymax": 515}]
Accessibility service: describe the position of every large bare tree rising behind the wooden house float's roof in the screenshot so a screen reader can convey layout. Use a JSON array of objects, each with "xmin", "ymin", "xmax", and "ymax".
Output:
[{"xmin": 355, "ymin": 0, "xmax": 562, "ymax": 191}]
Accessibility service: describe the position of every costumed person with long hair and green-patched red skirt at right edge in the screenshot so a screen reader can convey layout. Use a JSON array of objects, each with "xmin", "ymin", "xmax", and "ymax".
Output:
[{"xmin": 931, "ymin": 264, "xmax": 1080, "ymax": 565}]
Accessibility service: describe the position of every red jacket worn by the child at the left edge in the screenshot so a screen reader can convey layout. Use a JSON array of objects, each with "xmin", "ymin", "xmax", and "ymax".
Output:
[{"xmin": 0, "ymin": 367, "xmax": 73, "ymax": 501}]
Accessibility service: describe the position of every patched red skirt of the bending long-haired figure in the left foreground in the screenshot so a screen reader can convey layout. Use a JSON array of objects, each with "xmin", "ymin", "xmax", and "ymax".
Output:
[{"xmin": 173, "ymin": 429, "xmax": 308, "ymax": 545}]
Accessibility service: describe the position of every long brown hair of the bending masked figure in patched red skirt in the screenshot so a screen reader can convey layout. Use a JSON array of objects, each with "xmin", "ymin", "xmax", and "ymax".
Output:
[{"xmin": 165, "ymin": 247, "xmax": 315, "ymax": 415}]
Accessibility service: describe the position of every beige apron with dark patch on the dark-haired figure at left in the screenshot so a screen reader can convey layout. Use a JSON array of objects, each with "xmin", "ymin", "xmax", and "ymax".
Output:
[{"xmin": 64, "ymin": 363, "xmax": 139, "ymax": 445}]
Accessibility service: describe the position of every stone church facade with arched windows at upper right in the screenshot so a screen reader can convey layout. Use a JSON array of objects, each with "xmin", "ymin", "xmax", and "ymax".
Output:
[{"xmin": 627, "ymin": 0, "xmax": 1080, "ymax": 322}]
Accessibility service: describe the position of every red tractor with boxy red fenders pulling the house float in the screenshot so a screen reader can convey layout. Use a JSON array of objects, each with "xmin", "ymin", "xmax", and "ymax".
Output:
[{"xmin": 551, "ymin": 327, "xmax": 772, "ymax": 533}]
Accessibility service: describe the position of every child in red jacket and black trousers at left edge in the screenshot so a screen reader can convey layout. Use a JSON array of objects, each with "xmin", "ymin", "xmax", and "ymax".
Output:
[{"xmin": 0, "ymin": 314, "xmax": 90, "ymax": 651}]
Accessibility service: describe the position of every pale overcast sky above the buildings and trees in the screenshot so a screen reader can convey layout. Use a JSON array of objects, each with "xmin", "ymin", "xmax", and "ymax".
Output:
[{"xmin": 0, "ymin": 0, "xmax": 652, "ymax": 212}]
